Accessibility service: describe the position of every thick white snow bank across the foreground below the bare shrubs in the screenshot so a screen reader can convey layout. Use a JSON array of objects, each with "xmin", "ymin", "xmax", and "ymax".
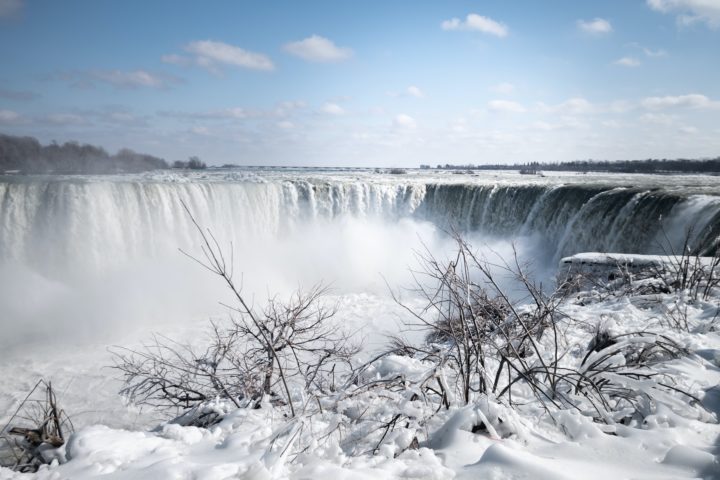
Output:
[{"xmin": 0, "ymin": 253, "xmax": 720, "ymax": 480}]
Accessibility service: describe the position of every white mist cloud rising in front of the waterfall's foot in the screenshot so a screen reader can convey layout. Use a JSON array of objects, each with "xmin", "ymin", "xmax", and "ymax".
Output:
[{"xmin": 0, "ymin": 213, "xmax": 552, "ymax": 351}]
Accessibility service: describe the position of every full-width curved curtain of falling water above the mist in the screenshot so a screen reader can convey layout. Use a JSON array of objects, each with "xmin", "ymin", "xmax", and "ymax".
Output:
[{"xmin": 0, "ymin": 172, "xmax": 720, "ymax": 273}]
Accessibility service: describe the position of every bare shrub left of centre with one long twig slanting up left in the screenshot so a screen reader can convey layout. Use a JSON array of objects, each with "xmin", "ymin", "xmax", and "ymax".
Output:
[{"xmin": 114, "ymin": 204, "xmax": 357, "ymax": 417}]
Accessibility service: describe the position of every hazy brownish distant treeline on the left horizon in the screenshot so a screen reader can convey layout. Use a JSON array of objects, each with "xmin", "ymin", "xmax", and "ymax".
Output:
[{"xmin": 0, "ymin": 134, "xmax": 168, "ymax": 174}]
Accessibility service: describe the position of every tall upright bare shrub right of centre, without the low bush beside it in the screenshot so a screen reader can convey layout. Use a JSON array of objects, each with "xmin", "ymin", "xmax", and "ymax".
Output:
[{"xmin": 388, "ymin": 235, "xmax": 563, "ymax": 412}]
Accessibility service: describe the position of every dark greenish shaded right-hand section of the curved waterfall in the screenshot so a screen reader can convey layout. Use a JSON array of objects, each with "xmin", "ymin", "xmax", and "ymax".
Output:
[{"xmin": 419, "ymin": 184, "xmax": 720, "ymax": 260}]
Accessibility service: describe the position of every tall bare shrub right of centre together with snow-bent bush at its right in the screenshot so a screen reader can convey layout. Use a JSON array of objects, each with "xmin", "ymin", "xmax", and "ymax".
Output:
[{"xmin": 376, "ymin": 232, "xmax": 702, "ymax": 438}]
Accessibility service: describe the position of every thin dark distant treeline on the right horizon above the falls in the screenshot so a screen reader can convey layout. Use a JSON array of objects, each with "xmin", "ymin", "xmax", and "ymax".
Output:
[{"xmin": 420, "ymin": 157, "xmax": 720, "ymax": 174}]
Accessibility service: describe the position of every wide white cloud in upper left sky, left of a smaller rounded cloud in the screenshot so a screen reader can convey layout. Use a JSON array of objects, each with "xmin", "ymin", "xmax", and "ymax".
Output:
[{"xmin": 161, "ymin": 40, "xmax": 275, "ymax": 73}]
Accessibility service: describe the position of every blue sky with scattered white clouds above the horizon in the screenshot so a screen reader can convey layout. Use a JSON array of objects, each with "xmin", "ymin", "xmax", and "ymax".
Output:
[{"xmin": 0, "ymin": 0, "xmax": 720, "ymax": 166}]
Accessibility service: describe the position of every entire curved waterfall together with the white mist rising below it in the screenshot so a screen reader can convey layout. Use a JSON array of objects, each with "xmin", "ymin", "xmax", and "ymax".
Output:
[{"xmin": 0, "ymin": 171, "xmax": 720, "ymax": 347}]
